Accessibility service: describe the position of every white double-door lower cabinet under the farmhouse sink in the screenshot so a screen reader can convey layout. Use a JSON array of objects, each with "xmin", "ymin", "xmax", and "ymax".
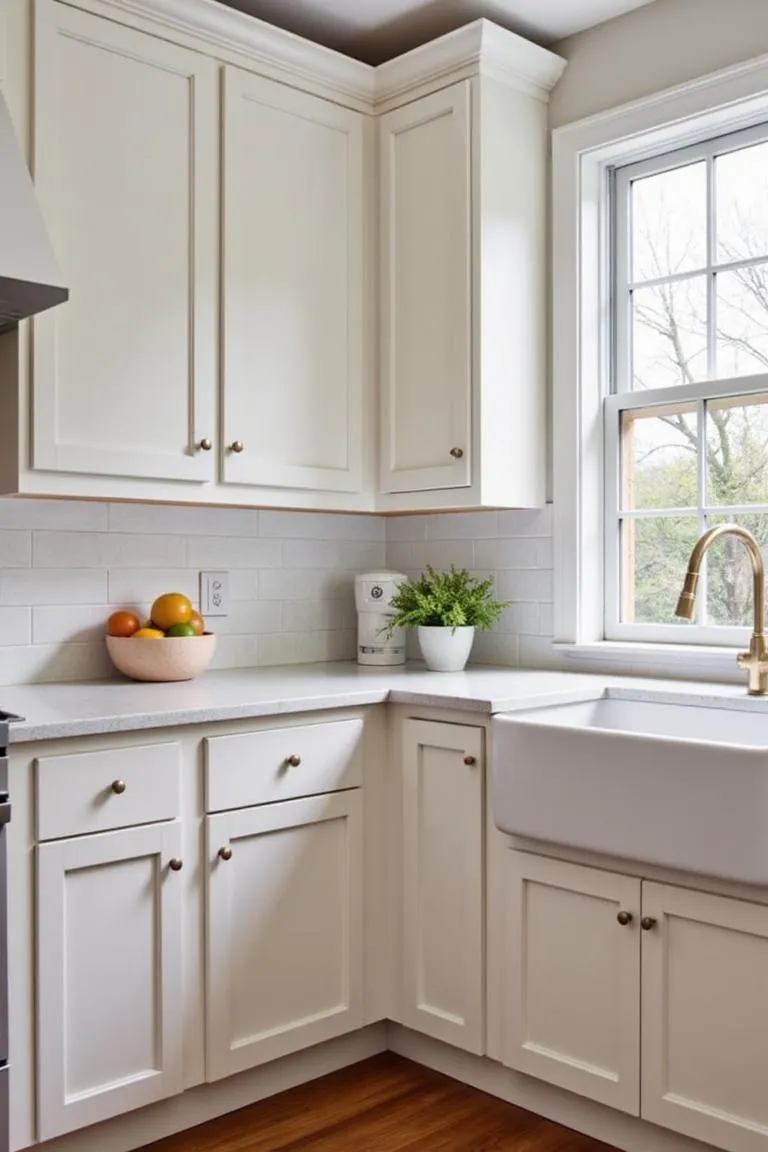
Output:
[{"xmin": 503, "ymin": 849, "xmax": 768, "ymax": 1152}]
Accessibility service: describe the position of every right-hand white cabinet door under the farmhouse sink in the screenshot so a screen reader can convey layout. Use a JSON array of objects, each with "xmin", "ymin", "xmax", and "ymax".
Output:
[{"xmin": 641, "ymin": 884, "xmax": 768, "ymax": 1152}]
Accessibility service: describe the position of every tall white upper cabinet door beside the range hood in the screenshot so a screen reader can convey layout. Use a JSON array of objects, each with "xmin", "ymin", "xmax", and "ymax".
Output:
[{"xmin": 32, "ymin": 0, "xmax": 219, "ymax": 482}]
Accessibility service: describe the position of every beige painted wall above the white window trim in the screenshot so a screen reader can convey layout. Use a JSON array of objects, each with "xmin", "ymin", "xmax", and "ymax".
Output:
[{"xmin": 550, "ymin": 0, "xmax": 768, "ymax": 128}]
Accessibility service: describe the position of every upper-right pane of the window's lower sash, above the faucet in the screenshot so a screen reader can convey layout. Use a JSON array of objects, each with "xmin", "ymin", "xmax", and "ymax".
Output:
[{"xmin": 706, "ymin": 395, "xmax": 768, "ymax": 505}]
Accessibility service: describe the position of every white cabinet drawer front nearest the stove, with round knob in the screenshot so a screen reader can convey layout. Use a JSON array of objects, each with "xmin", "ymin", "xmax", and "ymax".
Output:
[{"xmin": 36, "ymin": 743, "xmax": 180, "ymax": 840}]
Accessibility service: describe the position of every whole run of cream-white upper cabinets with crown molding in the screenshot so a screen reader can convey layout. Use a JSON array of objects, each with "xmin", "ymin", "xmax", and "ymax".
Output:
[{"xmin": 0, "ymin": 0, "xmax": 563, "ymax": 511}]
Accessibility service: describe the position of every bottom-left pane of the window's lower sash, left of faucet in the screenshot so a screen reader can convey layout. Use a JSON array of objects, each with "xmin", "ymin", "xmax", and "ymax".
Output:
[{"xmin": 622, "ymin": 516, "xmax": 699, "ymax": 624}]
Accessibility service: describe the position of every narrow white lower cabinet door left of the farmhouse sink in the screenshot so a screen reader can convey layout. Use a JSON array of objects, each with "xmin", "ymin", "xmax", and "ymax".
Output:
[{"xmin": 401, "ymin": 720, "xmax": 485, "ymax": 1054}]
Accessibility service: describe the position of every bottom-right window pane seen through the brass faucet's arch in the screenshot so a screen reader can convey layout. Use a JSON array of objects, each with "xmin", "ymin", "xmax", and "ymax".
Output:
[{"xmin": 707, "ymin": 513, "xmax": 768, "ymax": 628}]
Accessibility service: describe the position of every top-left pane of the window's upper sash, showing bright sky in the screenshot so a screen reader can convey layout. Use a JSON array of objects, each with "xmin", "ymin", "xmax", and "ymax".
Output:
[{"xmin": 631, "ymin": 160, "xmax": 707, "ymax": 281}]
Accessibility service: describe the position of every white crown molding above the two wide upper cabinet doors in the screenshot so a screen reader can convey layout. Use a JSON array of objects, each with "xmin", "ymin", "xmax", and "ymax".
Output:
[{"xmin": 94, "ymin": 0, "xmax": 375, "ymax": 108}]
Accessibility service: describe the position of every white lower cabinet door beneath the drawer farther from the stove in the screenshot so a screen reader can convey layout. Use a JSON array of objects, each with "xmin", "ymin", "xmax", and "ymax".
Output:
[{"xmin": 206, "ymin": 789, "xmax": 363, "ymax": 1081}]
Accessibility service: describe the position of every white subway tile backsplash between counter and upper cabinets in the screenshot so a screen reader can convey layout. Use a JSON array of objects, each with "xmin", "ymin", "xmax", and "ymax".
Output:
[{"xmin": 0, "ymin": 500, "xmax": 556, "ymax": 684}]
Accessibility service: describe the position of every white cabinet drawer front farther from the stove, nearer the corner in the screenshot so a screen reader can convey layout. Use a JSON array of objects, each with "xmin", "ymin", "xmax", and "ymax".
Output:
[{"xmin": 205, "ymin": 719, "xmax": 363, "ymax": 812}]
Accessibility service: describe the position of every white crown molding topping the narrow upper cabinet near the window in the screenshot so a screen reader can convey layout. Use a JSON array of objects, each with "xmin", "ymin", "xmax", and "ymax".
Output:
[{"xmin": 374, "ymin": 20, "xmax": 567, "ymax": 111}]
